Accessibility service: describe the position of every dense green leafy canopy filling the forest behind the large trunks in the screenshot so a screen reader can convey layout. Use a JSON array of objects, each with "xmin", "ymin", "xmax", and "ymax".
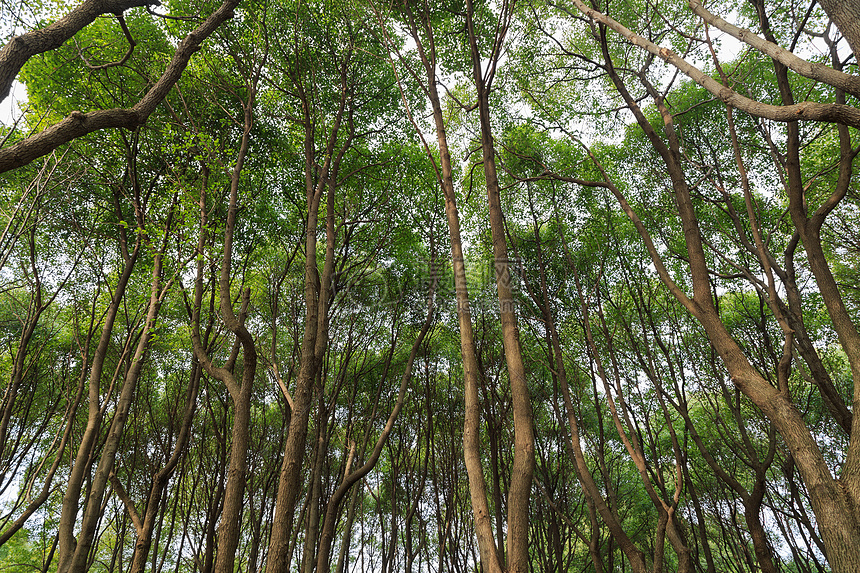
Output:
[{"xmin": 0, "ymin": 0, "xmax": 860, "ymax": 572}]
